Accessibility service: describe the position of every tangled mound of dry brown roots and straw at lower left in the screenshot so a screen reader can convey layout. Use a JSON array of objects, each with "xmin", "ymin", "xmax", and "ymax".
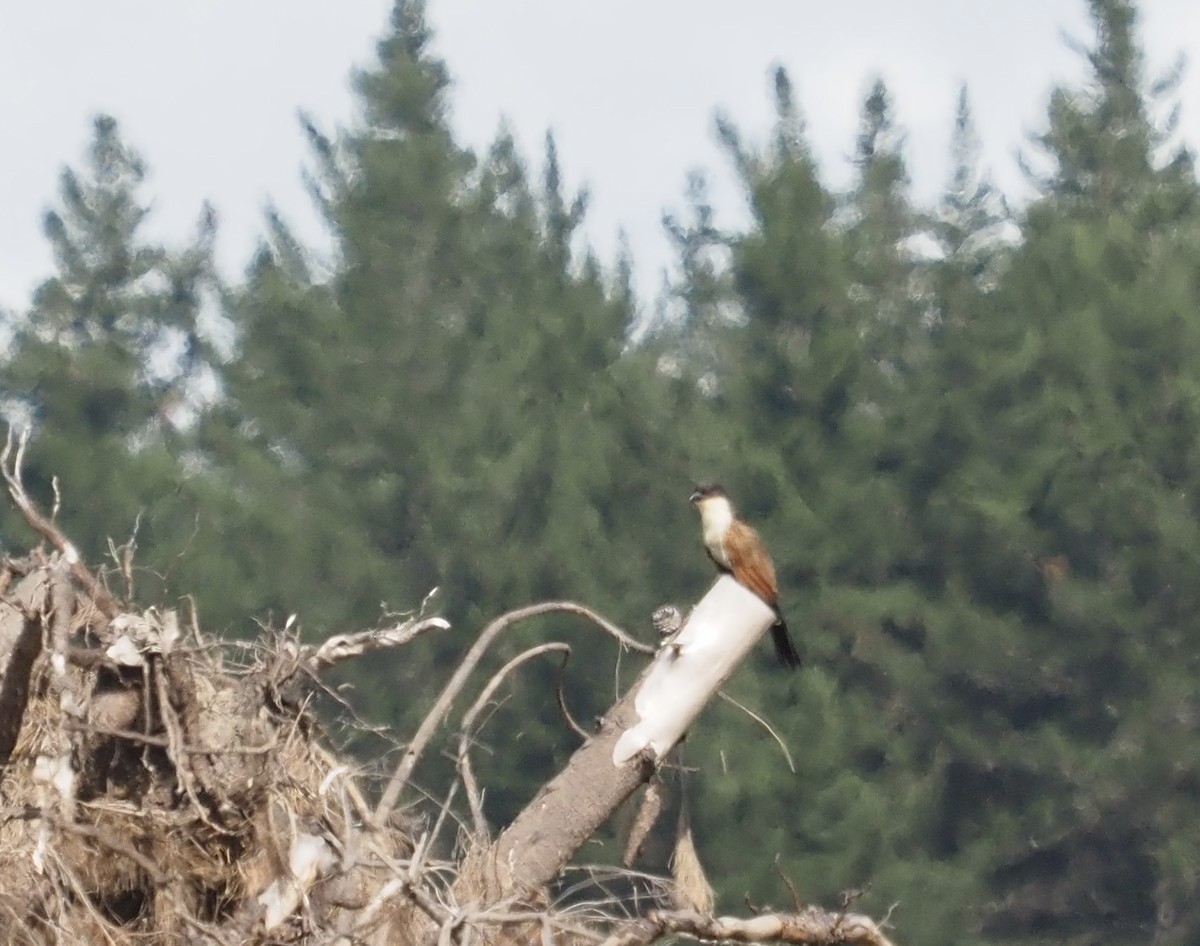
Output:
[{"xmin": 0, "ymin": 553, "xmax": 412, "ymax": 944}]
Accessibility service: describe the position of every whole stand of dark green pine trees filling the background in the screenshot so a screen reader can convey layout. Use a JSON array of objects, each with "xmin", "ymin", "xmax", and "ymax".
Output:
[{"xmin": 0, "ymin": 0, "xmax": 1200, "ymax": 946}]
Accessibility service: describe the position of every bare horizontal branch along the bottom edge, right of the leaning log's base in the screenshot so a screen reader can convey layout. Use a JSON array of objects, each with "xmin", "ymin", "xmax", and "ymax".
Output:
[{"xmin": 604, "ymin": 906, "xmax": 894, "ymax": 946}]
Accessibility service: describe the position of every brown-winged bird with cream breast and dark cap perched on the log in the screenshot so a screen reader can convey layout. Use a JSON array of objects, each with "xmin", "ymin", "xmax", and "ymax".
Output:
[{"xmin": 690, "ymin": 483, "xmax": 800, "ymax": 670}]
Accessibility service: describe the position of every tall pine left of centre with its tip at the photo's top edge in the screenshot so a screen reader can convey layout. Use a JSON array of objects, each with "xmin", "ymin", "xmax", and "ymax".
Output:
[{"xmin": 209, "ymin": 2, "xmax": 473, "ymax": 630}]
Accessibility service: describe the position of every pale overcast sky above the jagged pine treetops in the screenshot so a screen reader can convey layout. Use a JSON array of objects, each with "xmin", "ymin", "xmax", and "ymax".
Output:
[{"xmin": 0, "ymin": 0, "xmax": 1200, "ymax": 307}]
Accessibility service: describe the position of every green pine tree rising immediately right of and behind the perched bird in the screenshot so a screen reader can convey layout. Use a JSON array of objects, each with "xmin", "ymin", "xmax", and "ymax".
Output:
[{"xmin": 657, "ymin": 71, "xmax": 953, "ymax": 927}]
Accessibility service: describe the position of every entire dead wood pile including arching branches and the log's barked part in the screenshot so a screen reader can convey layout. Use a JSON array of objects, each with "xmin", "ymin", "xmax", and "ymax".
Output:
[{"xmin": 0, "ymin": 429, "xmax": 902, "ymax": 946}]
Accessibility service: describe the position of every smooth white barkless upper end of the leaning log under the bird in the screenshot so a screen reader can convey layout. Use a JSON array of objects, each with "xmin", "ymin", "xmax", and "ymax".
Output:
[{"xmin": 612, "ymin": 575, "xmax": 775, "ymax": 766}]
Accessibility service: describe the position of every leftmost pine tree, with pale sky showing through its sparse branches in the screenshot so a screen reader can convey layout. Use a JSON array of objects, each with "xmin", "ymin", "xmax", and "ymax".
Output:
[{"xmin": 0, "ymin": 115, "xmax": 221, "ymax": 594}]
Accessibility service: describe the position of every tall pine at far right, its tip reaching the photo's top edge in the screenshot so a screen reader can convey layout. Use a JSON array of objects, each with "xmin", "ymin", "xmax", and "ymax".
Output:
[{"xmin": 904, "ymin": 2, "xmax": 1200, "ymax": 942}]
